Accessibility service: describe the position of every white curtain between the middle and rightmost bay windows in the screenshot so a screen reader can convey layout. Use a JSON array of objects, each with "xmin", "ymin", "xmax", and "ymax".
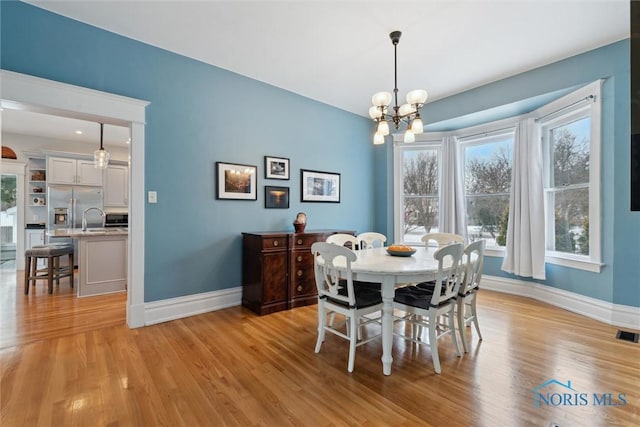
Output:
[{"xmin": 502, "ymin": 119, "xmax": 545, "ymax": 279}]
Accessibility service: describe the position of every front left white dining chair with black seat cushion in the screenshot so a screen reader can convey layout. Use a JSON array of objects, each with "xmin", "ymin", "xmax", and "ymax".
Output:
[{"xmin": 311, "ymin": 242, "xmax": 382, "ymax": 372}]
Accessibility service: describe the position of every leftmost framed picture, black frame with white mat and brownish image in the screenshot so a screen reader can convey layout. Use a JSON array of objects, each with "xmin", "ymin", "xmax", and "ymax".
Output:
[{"xmin": 216, "ymin": 162, "xmax": 258, "ymax": 200}]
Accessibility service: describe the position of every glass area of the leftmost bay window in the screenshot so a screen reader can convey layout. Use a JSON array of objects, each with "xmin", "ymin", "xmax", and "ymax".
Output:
[{"xmin": 402, "ymin": 149, "xmax": 439, "ymax": 243}]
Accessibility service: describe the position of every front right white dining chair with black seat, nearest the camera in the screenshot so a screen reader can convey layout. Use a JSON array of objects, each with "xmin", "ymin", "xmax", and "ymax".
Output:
[{"xmin": 393, "ymin": 243, "xmax": 462, "ymax": 374}]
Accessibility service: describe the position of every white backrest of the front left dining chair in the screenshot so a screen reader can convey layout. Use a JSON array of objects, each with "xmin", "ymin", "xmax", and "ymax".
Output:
[{"xmin": 311, "ymin": 242, "xmax": 357, "ymax": 307}]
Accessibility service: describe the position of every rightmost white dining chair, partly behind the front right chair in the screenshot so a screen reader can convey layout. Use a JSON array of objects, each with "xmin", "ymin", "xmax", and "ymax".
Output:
[{"xmin": 456, "ymin": 239, "xmax": 485, "ymax": 353}]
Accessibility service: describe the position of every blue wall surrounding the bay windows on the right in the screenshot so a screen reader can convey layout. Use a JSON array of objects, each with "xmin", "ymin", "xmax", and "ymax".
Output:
[{"xmin": 375, "ymin": 40, "xmax": 640, "ymax": 307}]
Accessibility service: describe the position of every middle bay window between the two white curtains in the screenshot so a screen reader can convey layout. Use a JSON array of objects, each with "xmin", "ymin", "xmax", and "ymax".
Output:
[{"xmin": 461, "ymin": 132, "xmax": 513, "ymax": 247}]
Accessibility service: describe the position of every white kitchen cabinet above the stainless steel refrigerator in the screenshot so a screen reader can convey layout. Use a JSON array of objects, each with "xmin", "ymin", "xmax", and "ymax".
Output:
[{"xmin": 47, "ymin": 157, "xmax": 102, "ymax": 187}]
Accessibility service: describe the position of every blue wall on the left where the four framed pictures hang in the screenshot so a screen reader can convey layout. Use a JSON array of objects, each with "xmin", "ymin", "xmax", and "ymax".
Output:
[{"xmin": 0, "ymin": 1, "xmax": 375, "ymax": 302}]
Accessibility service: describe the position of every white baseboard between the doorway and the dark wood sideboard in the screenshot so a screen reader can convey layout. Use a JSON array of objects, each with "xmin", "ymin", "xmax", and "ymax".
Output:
[{"xmin": 144, "ymin": 286, "xmax": 242, "ymax": 326}]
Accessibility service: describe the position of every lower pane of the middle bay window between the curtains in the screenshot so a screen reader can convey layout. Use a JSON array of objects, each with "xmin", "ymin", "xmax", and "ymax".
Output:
[{"xmin": 467, "ymin": 195, "xmax": 509, "ymax": 246}]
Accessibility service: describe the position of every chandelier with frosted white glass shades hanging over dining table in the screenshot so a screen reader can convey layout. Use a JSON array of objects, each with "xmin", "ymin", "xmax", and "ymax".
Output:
[{"xmin": 369, "ymin": 31, "xmax": 427, "ymax": 144}]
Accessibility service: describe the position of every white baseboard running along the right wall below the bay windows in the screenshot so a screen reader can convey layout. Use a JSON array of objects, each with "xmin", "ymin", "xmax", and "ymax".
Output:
[{"xmin": 480, "ymin": 275, "xmax": 640, "ymax": 330}]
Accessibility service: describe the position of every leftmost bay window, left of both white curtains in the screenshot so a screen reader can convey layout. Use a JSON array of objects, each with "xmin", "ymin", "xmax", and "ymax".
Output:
[{"xmin": 395, "ymin": 144, "xmax": 441, "ymax": 244}]
